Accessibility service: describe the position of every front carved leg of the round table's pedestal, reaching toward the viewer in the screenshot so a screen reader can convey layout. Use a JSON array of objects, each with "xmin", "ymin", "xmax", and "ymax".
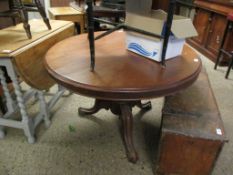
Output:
[{"xmin": 120, "ymin": 104, "xmax": 138, "ymax": 163}]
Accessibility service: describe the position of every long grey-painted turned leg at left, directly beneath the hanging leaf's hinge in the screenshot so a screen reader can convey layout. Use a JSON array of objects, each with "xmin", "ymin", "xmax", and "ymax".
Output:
[{"xmin": 7, "ymin": 60, "xmax": 35, "ymax": 143}]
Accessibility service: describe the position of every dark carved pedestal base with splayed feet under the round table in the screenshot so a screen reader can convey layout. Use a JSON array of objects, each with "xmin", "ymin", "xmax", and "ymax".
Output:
[{"xmin": 79, "ymin": 99, "xmax": 151, "ymax": 163}]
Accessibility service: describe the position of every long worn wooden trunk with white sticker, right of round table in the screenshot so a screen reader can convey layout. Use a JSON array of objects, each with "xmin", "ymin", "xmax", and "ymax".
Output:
[{"xmin": 157, "ymin": 68, "xmax": 226, "ymax": 175}]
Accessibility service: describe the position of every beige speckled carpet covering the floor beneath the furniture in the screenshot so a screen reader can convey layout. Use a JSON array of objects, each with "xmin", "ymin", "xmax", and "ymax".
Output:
[{"xmin": 0, "ymin": 46, "xmax": 233, "ymax": 175}]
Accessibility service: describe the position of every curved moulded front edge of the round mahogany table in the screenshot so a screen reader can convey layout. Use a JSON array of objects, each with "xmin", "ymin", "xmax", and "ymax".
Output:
[{"xmin": 44, "ymin": 58, "xmax": 202, "ymax": 101}]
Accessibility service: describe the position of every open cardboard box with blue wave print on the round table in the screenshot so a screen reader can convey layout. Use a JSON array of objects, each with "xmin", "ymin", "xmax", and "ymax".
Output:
[{"xmin": 126, "ymin": 10, "xmax": 197, "ymax": 62}]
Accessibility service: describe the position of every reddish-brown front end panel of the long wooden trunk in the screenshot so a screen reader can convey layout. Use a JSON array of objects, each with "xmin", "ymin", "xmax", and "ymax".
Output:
[{"xmin": 157, "ymin": 133, "xmax": 222, "ymax": 175}]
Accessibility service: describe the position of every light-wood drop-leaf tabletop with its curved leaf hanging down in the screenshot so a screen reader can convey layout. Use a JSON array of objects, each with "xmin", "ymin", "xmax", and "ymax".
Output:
[{"xmin": 0, "ymin": 20, "xmax": 74, "ymax": 90}]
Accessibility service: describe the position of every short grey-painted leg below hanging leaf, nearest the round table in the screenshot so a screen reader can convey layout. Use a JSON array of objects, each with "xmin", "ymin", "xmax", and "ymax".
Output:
[{"xmin": 37, "ymin": 91, "xmax": 51, "ymax": 127}]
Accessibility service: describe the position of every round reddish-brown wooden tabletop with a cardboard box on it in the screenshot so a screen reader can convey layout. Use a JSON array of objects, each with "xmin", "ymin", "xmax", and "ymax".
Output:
[{"xmin": 45, "ymin": 31, "xmax": 202, "ymax": 101}]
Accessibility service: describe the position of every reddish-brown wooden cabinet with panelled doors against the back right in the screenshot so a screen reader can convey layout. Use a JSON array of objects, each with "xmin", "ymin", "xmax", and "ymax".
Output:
[{"xmin": 188, "ymin": 0, "xmax": 233, "ymax": 65}]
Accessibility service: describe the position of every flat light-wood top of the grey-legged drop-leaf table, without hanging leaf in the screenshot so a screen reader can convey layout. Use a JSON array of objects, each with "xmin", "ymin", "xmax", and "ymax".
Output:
[{"xmin": 0, "ymin": 19, "xmax": 73, "ymax": 59}]
